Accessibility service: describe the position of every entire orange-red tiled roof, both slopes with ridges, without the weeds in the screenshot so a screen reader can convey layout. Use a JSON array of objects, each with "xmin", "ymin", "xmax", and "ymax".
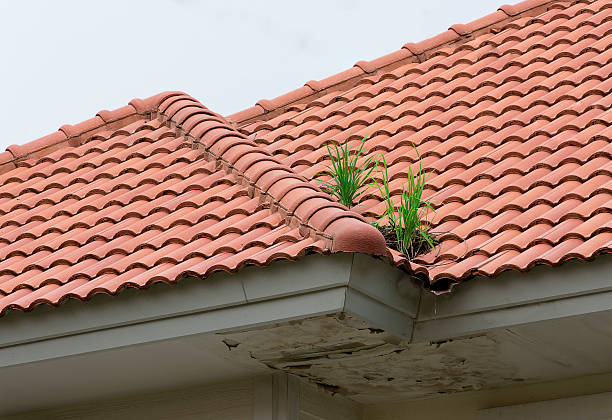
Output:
[{"xmin": 0, "ymin": 0, "xmax": 612, "ymax": 314}]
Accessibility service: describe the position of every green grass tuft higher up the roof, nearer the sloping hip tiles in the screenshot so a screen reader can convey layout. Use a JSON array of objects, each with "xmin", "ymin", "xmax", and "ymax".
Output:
[{"xmin": 315, "ymin": 138, "xmax": 378, "ymax": 208}]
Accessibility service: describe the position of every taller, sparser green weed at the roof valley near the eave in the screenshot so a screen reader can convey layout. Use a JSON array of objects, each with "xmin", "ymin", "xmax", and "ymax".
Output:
[{"xmin": 373, "ymin": 147, "xmax": 437, "ymax": 258}]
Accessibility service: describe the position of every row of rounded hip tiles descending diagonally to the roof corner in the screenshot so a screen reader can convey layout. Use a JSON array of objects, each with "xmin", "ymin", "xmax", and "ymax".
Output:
[{"xmin": 146, "ymin": 92, "xmax": 388, "ymax": 256}]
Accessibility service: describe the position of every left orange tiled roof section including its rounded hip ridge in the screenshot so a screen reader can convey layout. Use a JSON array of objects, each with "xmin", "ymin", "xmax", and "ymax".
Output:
[{"xmin": 0, "ymin": 92, "xmax": 386, "ymax": 314}]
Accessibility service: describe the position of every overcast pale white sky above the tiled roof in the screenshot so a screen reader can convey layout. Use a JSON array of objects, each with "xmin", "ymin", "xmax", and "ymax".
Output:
[{"xmin": 0, "ymin": 0, "xmax": 494, "ymax": 151}]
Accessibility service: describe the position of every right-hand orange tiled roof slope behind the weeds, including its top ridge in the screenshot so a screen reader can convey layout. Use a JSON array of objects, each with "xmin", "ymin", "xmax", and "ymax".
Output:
[{"xmin": 230, "ymin": 0, "xmax": 612, "ymax": 290}]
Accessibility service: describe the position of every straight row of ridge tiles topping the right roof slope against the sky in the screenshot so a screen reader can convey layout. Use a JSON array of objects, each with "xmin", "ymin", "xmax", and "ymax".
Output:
[{"xmin": 227, "ymin": 0, "xmax": 589, "ymax": 125}]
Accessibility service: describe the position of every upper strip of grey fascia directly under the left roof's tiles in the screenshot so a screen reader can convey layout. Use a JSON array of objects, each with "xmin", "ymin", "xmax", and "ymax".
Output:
[{"xmin": 0, "ymin": 255, "xmax": 351, "ymax": 348}]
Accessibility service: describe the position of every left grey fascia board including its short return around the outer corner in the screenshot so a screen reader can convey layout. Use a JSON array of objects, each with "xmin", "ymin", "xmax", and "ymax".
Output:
[{"xmin": 0, "ymin": 254, "xmax": 420, "ymax": 367}]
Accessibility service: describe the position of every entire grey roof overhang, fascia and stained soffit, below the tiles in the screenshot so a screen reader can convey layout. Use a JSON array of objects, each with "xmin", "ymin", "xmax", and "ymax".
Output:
[{"xmin": 0, "ymin": 253, "xmax": 612, "ymax": 411}]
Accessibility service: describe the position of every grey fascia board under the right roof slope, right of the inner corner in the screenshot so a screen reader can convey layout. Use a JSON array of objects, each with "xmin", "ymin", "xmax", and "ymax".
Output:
[{"xmin": 413, "ymin": 255, "xmax": 612, "ymax": 342}]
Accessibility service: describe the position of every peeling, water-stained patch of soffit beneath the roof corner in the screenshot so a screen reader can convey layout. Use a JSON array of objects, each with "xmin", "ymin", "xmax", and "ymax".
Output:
[{"xmin": 220, "ymin": 314, "xmax": 522, "ymax": 402}]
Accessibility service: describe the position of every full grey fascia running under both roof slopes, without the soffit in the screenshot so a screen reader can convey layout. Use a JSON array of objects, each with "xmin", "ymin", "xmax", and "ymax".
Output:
[{"xmin": 0, "ymin": 254, "xmax": 612, "ymax": 367}]
